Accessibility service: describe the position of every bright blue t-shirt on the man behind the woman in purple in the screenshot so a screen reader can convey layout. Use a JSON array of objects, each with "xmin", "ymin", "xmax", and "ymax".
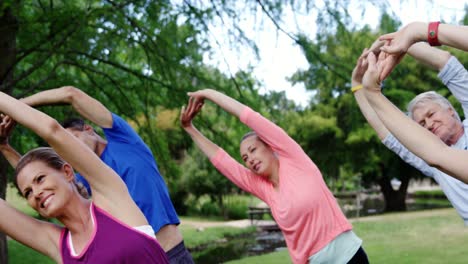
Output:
[{"xmin": 76, "ymin": 113, "xmax": 180, "ymax": 232}]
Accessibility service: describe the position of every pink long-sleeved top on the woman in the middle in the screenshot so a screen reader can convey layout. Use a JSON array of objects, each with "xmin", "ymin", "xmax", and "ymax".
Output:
[{"xmin": 211, "ymin": 107, "xmax": 352, "ymax": 263}]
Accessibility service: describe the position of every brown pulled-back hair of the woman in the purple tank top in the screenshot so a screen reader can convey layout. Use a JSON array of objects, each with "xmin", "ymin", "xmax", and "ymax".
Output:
[{"xmin": 13, "ymin": 147, "xmax": 89, "ymax": 199}]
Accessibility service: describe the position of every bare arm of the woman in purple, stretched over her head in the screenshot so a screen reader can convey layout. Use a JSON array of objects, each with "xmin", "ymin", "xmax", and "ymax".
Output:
[{"xmin": 0, "ymin": 93, "xmax": 147, "ymax": 226}]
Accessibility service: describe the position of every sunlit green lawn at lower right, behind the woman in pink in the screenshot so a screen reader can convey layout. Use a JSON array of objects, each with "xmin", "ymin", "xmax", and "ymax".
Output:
[{"xmin": 227, "ymin": 209, "xmax": 468, "ymax": 264}]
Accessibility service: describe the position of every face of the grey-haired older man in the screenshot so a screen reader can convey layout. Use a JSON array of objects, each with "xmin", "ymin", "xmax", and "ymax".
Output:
[{"xmin": 413, "ymin": 102, "xmax": 461, "ymax": 145}]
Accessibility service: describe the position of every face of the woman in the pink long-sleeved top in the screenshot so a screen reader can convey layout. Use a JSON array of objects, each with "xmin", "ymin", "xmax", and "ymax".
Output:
[{"xmin": 240, "ymin": 135, "xmax": 278, "ymax": 178}]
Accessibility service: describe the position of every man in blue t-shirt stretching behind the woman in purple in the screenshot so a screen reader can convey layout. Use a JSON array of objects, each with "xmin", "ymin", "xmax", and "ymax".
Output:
[{"xmin": 0, "ymin": 86, "xmax": 193, "ymax": 263}]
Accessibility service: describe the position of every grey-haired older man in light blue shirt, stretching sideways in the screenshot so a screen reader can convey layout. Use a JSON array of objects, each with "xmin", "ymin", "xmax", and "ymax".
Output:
[{"xmin": 352, "ymin": 42, "xmax": 468, "ymax": 226}]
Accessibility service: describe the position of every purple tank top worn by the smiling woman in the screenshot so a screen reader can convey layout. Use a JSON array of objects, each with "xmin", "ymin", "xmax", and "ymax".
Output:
[{"xmin": 60, "ymin": 204, "xmax": 169, "ymax": 264}]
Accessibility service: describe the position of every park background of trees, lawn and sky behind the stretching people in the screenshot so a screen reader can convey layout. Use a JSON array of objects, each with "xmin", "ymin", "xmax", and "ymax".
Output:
[{"xmin": 0, "ymin": 0, "xmax": 468, "ymax": 263}]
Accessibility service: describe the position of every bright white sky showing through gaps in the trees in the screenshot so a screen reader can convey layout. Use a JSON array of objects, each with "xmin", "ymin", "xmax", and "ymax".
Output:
[{"xmin": 205, "ymin": 0, "xmax": 468, "ymax": 106}]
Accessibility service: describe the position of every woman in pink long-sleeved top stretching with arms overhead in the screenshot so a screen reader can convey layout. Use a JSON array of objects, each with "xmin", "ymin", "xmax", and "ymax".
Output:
[{"xmin": 180, "ymin": 89, "xmax": 368, "ymax": 263}]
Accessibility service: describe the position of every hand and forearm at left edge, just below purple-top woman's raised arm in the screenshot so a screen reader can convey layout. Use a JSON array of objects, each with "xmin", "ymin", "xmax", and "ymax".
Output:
[{"xmin": 0, "ymin": 114, "xmax": 21, "ymax": 168}]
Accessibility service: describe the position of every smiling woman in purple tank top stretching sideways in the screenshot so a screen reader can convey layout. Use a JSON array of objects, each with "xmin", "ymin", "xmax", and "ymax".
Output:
[{"xmin": 0, "ymin": 93, "xmax": 168, "ymax": 264}]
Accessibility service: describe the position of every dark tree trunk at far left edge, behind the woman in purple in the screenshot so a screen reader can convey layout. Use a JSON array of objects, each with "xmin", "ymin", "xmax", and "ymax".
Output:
[{"xmin": 0, "ymin": 0, "xmax": 18, "ymax": 263}]
